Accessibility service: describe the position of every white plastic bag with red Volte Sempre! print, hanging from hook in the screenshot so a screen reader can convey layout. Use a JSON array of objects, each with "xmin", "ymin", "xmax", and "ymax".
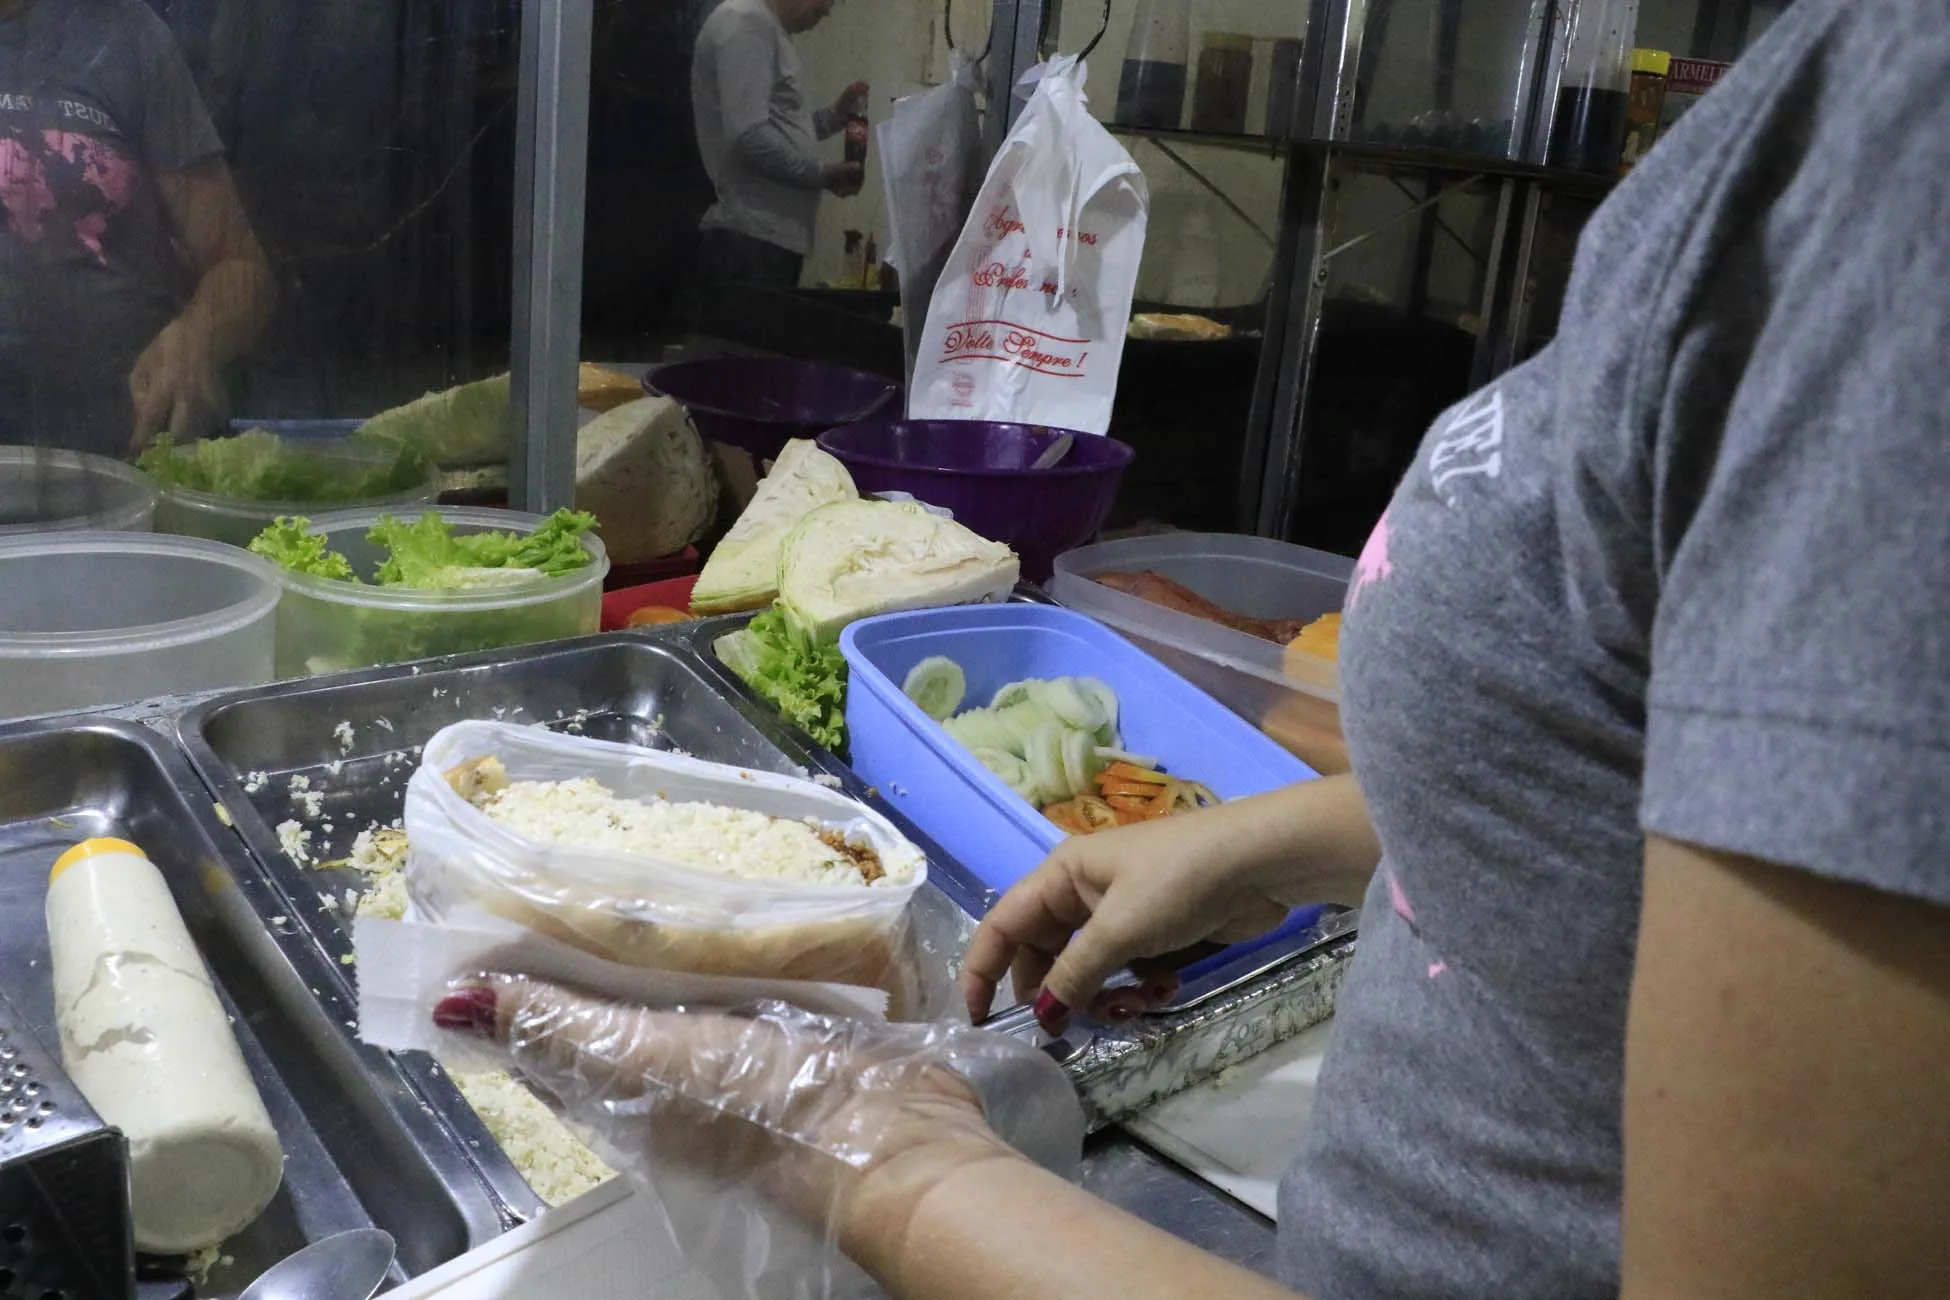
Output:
[{"xmin": 907, "ymin": 57, "xmax": 1151, "ymax": 433}]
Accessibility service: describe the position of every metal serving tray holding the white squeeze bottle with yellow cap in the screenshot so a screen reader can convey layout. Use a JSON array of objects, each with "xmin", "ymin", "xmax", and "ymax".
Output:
[{"xmin": 0, "ymin": 719, "xmax": 501, "ymax": 1296}]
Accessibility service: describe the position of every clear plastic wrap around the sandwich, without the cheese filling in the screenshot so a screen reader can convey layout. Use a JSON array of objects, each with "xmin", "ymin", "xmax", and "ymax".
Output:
[{"xmin": 406, "ymin": 721, "xmax": 948, "ymax": 1017}]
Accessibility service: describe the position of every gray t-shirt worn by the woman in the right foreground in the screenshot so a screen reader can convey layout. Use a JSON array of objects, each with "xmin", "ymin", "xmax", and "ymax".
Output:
[{"xmin": 1279, "ymin": 0, "xmax": 1950, "ymax": 1300}]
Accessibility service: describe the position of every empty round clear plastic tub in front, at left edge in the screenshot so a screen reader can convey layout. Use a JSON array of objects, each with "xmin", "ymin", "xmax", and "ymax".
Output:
[{"xmin": 0, "ymin": 532, "xmax": 279, "ymax": 717}]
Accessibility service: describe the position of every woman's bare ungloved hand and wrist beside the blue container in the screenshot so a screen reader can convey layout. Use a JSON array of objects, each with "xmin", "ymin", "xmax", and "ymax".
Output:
[{"xmin": 961, "ymin": 776, "xmax": 1381, "ymax": 1029}]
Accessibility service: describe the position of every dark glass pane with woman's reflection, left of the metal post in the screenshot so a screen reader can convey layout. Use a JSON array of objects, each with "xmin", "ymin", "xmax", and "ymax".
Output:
[{"xmin": 0, "ymin": 0, "xmax": 519, "ymax": 514}]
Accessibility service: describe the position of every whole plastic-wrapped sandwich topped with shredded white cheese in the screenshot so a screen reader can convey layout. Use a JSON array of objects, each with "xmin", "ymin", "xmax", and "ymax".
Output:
[{"xmin": 406, "ymin": 721, "xmax": 948, "ymax": 1017}]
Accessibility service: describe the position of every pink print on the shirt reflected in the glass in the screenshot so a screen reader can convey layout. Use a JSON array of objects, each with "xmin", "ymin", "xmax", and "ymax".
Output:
[{"xmin": 0, "ymin": 131, "xmax": 140, "ymax": 267}]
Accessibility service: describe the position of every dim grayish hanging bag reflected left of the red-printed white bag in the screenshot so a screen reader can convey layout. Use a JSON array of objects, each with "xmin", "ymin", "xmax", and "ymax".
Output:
[{"xmin": 874, "ymin": 51, "xmax": 981, "ymax": 393}]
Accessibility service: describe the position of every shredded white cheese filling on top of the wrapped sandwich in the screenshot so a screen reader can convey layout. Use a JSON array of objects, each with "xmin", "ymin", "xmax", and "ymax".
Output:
[{"xmin": 476, "ymin": 778, "xmax": 915, "ymax": 885}]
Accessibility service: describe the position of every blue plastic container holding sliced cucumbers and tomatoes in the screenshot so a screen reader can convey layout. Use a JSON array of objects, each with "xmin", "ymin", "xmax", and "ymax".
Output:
[{"xmin": 840, "ymin": 604, "xmax": 1314, "ymax": 889}]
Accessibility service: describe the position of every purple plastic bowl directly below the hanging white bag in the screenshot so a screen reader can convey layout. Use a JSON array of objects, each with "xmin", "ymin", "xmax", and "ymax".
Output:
[{"xmin": 819, "ymin": 419, "xmax": 1137, "ymax": 583}]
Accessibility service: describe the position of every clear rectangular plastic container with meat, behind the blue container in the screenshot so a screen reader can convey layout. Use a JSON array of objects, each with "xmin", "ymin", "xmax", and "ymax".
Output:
[{"xmin": 1049, "ymin": 532, "xmax": 1353, "ymax": 772}]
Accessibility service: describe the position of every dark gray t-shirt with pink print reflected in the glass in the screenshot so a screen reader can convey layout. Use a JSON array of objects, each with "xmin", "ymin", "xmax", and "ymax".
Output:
[{"xmin": 0, "ymin": 0, "xmax": 222, "ymax": 456}]
